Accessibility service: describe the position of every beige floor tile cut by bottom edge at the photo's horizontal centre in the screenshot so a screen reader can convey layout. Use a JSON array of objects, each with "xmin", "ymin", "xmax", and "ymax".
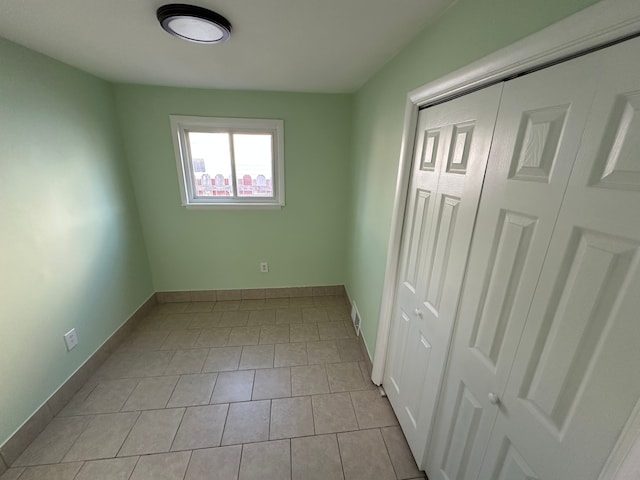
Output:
[{"xmin": 291, "ymin": 435, "xmax": 344, "ymax": 480}]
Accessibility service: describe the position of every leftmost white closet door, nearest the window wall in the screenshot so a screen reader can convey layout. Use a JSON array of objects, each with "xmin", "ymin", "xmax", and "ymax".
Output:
[{"xmin": 384, "ymin": 85, "xmax": 502, "ymax": 465}]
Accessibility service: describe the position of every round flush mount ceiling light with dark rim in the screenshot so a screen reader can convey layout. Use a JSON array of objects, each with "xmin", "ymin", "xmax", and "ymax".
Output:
[{"xmin": 156, "ymin": 3, "xmax": 231, "ymax": 44}]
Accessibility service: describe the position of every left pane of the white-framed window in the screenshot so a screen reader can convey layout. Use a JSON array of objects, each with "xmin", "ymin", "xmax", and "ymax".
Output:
[{"xmin": 188, "ymin": 132, "xmax": 233, "ymax": 197}]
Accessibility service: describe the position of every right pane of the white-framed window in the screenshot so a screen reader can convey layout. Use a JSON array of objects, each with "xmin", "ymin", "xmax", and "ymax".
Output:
[{"xmin": 233, "ymin": 133, "xmax": 273, "ymax": 197}]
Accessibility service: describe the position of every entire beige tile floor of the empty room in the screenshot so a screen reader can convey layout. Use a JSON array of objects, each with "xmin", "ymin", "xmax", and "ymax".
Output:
[{"xmin": 1, "ymin": 297, "xmax": 425, "ymax": 480}]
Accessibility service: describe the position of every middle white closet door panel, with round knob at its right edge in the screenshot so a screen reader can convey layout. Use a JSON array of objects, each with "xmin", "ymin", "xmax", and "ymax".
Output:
[{"xmin": 426, "ymin": 50, "xmax": 595, "ymax": 480}]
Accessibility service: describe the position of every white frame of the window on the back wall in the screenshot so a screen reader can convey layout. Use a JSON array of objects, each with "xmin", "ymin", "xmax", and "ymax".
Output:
[{"xmin": 169, "ymin": 115, "xmax": 284, "ymax": 209}]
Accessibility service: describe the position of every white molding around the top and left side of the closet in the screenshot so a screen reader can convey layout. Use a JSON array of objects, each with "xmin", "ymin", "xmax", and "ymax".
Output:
[{"xmin": 371, "ymin": 0, "xmax": 640, "ymax": 385}]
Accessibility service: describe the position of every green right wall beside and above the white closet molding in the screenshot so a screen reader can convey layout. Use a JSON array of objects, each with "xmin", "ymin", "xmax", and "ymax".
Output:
[{"xmin": 346, "ymin": 0, "xmax": 595, "ymax": 354}]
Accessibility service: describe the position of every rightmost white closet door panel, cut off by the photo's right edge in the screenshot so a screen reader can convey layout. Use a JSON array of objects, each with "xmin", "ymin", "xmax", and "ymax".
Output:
[{"xmin": 480, "ymin": 35, "xmax": 640, "ymax": 480}]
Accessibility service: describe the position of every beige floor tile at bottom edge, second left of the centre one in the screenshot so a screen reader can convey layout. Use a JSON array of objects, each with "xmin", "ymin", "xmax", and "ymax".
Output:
[{"xmin": 185, "ymin": 445, "xmax": 242, "ymax": 480}]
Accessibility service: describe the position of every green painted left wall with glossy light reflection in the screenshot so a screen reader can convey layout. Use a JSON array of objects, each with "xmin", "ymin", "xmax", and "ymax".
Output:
[{"xmin": 0, "ymin": 39, "xmax": 153, "ymax": 445}]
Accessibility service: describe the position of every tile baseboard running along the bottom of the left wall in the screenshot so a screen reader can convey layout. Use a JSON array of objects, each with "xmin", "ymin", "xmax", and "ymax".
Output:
[{"xmin": 0, "ymin": 293, "xmax": 157, "ymax": 468}]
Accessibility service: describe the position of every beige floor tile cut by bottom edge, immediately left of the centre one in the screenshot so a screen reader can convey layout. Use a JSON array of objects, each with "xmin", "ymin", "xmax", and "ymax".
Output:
[{"xmin": 238, "ymin": 440, "xmax": 291, "ymax": 480}]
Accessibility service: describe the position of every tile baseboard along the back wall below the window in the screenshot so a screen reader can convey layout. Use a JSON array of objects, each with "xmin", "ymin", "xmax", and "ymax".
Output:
[{"xmin": 156, "ymin": 285, "xmax": 346, "ymax": 303}]
